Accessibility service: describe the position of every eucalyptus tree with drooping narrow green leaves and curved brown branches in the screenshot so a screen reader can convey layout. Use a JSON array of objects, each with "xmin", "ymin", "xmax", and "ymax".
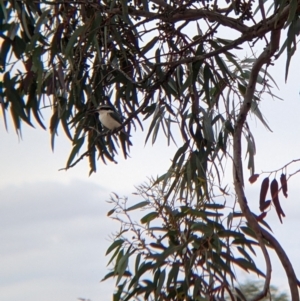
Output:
[{"xmin": 0, "ymin": 0, "xmax": 300, "ymax": 301}]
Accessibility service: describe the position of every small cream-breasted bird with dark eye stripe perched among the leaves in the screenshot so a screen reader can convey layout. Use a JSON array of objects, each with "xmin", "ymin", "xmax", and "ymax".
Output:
[{"xmin": 96, "ymin": 104, "xmax": 132, "ymax": 158}]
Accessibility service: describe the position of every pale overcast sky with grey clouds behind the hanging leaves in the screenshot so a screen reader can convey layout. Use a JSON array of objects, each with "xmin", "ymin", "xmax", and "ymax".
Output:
[{"xmin": 0, "ymin": 34, "xmax": 300, "ymax": 301}]
